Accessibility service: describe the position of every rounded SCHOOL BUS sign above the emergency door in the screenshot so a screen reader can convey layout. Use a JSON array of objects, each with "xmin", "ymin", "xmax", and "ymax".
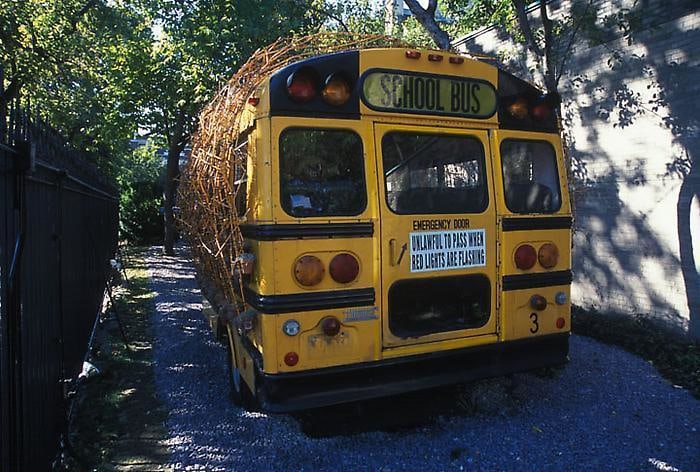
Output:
[{"xmin": 362, "ymin": 69, "xmax": 496, "ymax": 119}]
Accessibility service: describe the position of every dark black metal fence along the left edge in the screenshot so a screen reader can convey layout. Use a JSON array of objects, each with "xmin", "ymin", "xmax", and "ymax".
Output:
[{"xmin": 0, "ymin": 109, "xmax": 119, "ymax": 470}]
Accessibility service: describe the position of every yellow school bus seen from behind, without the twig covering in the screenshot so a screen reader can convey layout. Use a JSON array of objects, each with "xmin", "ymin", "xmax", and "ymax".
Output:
[{"xmin": 220, "ymin": 48, "xmax": 572, "ymax": 412}]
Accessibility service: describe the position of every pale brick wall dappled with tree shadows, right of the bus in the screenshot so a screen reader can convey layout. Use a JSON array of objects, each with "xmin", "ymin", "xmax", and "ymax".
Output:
[{"xmin": 456, "ymin": 0, "xmax": 700, "ymax": 336}]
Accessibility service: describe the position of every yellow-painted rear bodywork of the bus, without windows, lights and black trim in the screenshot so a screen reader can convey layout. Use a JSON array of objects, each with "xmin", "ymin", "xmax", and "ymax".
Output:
[{"xmin": 232, "ymin": 49, "xmax": 571, "ymax": 380}]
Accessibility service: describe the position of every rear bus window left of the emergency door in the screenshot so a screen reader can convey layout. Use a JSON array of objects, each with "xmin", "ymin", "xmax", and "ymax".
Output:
[{"xmin": 280, "ymin": 128, "xmax": 367, "ymax": 217}]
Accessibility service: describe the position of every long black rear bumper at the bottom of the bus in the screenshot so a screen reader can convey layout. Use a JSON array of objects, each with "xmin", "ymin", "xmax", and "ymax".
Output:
[{"xmin": 256, "ymin": 333, "xmax": 569, "ymax": 413}]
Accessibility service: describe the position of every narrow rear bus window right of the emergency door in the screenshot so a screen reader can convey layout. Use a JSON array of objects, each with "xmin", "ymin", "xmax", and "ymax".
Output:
[{"xmin": 501, "ymin": 139, "xmax": 561, "ymax": 213}]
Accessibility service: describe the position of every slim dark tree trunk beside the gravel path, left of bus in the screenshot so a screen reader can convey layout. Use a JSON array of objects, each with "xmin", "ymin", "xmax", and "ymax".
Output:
[{"xmin": 163, "ymin": 112, "xmax": 185, "ymax": 256}]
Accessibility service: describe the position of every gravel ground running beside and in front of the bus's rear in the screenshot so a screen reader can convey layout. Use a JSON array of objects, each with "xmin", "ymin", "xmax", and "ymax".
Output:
[{"xmin": 147, "ymin": 248, "xmax": 700, "ymax": 471}]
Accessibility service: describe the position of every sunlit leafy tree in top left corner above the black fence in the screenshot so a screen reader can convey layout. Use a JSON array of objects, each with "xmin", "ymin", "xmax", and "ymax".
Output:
[{"xmin": 0, "ymin": 0, "xmax": 150, "ymax": 169}]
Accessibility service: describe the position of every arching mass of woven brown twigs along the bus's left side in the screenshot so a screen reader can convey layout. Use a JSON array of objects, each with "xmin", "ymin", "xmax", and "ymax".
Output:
[{"xmin": 178, "ymin": 33, "xmax": 407, "ymax": 311}]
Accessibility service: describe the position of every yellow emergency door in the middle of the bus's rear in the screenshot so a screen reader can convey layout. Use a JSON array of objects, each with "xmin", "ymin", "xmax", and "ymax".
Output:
[{"xmin": 374, "ymin": 124, "xmax": 497, "ymax": 352}]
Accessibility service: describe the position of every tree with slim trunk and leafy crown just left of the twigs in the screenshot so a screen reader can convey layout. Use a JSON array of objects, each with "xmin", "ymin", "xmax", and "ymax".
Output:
[{"xmin": 144, "ymin": 0, "xmax": 317, "ymax": 254}]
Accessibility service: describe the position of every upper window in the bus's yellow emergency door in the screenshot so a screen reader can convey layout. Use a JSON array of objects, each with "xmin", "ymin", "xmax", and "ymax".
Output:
[{"xmin": 382, "ymin": 132, "xmax": 488, "ymax": 214}]
